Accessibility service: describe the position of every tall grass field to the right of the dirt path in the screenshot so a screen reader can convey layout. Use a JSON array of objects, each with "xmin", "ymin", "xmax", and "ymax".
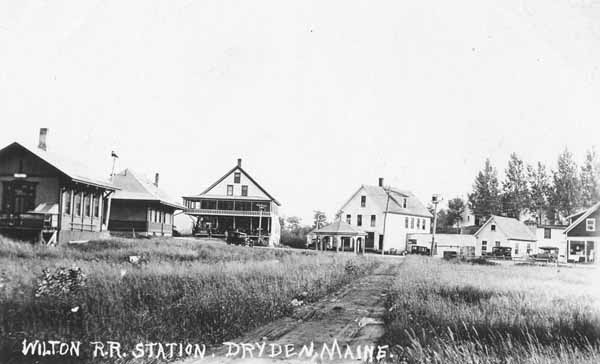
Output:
[{"xmin": 382, "ymin": 256, "xmax": 600, "ymax": 364}]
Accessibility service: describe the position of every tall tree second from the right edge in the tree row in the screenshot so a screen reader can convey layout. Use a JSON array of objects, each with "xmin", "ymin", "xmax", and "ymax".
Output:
[{"xmin": 550, "ymin": 148, "xmax": 581, "ymax": 222}]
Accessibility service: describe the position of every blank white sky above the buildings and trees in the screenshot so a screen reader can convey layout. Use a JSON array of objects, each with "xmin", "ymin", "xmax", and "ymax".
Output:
[{"xmin": 0, "ymin": 0, "xmax": 600, "ymax": 223}]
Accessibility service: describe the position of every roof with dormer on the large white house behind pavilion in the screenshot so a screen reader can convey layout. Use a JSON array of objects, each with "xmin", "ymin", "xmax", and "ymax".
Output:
[{"xmin": 340, "ymin": 185, "xmax": 433, "ymax": 218}]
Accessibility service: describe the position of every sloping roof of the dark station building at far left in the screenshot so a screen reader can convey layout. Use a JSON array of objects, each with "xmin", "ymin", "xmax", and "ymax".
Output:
[{"xmin": 0, "ymin": 142, "xmax": 118, "ymax": 191}]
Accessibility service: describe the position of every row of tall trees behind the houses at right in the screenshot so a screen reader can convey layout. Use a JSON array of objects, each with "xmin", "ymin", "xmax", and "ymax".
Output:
[{"xmin": 468, "ymin": 148, "xmax": 600, "ymax": 224}]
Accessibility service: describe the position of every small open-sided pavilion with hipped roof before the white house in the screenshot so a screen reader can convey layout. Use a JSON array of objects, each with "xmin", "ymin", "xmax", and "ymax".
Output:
[{"xmin": 311, "ymin": 220, "xmax": 367, "ymax": 253}]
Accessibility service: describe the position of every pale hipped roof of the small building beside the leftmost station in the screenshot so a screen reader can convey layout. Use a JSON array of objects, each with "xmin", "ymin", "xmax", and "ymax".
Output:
[{"xmin": 112, "ymin": 168, "xmax": 184, "ymax": 209}]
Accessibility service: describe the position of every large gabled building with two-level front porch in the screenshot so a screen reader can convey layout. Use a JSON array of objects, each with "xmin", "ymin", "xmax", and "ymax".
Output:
[{"xmin": 183, "ymin": 159, "xmax": 281, "ymax": 245}]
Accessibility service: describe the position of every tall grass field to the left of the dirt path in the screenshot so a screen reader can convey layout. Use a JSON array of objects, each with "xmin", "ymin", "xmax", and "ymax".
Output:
[{"xmin": 0, "ymin": 239, "xmax": 375, "ymax": 363}]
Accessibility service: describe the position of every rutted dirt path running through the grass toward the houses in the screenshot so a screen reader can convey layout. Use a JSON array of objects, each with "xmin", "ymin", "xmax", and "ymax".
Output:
[{"xmin": 184, "ymin": 258, "xmax": 403, "ymax": 364}]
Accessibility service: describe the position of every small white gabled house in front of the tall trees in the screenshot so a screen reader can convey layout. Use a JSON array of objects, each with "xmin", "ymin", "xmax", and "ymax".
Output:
[{"xmin": 475, "ymin": 216, "xmax": 537, "ymax": 258}]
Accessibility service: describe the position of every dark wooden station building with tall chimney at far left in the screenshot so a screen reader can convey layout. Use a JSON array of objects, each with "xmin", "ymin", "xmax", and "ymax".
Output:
[{"xmin": 0, "ymin": 129, "xmax": 117, "ymax": 244}]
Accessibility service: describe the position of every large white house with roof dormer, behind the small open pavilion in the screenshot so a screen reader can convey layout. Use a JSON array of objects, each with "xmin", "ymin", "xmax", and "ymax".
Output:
[{"xmin": 338, "ymin": 178, "xmax": 433, "ymax": 251}]
